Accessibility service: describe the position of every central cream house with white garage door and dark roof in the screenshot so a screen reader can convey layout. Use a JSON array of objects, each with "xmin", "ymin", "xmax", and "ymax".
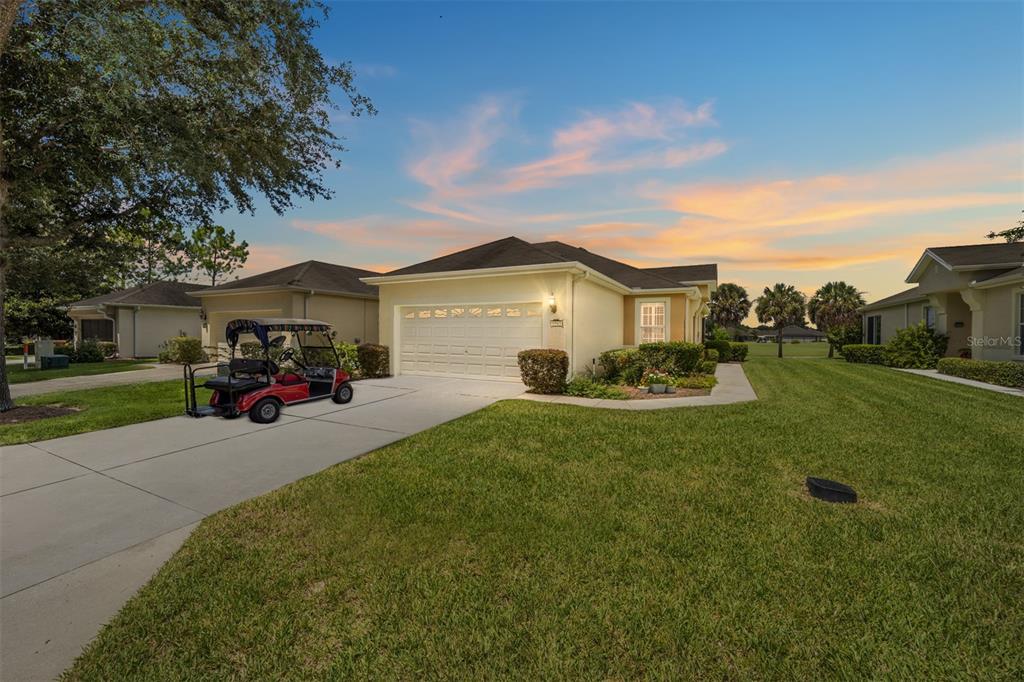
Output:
[{"xmin": 364, "ymin": 237, "xmax": 718, "ymax": 379}]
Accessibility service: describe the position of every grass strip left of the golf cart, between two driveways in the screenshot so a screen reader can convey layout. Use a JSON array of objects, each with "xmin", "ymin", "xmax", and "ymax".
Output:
[{"xmin": 0, "ymin": 380, "xmax": 210, "ymax": 445}]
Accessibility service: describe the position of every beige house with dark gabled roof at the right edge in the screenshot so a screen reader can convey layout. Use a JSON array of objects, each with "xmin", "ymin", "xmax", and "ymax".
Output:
[{"xmin": 860, "ymin": 243, "xmax": 1024, "ymax": 361}]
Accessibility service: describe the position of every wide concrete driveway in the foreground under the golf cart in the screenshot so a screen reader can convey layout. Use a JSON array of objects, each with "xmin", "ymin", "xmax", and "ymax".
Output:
[{"xmin": 0, "ymin": 372, "xmax": 523, "ymax": 680}]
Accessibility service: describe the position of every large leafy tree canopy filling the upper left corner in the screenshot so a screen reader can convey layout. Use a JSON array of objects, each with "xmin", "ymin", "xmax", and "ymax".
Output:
[{"xmin": 0, "ymin": 0, "xmax": 374, "ymax": 411}]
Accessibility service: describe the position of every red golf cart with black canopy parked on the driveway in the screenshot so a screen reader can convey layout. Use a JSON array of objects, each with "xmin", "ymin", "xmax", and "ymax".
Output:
[{"xmin": 184, "ymin": 318, "xmax": 352, "ymax": 424}]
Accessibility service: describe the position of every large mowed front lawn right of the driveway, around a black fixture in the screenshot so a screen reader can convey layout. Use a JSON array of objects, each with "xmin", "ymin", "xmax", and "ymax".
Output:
[{"xmin": 67, "ymin": 358, "xmax": 1024, "ymax": 680}]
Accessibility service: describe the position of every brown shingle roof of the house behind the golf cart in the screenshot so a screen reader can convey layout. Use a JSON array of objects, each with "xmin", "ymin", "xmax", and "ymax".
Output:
[{"xmin": 193, "ymin": 260, "xmax": 380, "ymax": 298}]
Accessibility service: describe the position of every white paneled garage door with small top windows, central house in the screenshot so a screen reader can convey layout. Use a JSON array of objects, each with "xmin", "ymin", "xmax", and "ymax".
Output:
[{"xmin": 398, "ymin": 303, "xmax": 544, "ymax": 379}]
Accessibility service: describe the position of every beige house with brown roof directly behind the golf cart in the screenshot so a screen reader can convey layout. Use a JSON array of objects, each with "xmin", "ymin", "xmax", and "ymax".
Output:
[{"xmin": 191, "ymin": 260, "xmax": 380, "ymax": 353}]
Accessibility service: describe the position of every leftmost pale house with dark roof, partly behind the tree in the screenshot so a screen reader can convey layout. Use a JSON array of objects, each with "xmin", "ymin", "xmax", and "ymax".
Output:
[{"xmin": 68, "ymin": 282, "xmax": 203, "ymax": 357}]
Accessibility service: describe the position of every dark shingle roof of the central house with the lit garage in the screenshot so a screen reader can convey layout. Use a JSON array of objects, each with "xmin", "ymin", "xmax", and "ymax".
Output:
[{"xmin": 372, "ymin": 237, "xmax": 715, "ymax": 290}]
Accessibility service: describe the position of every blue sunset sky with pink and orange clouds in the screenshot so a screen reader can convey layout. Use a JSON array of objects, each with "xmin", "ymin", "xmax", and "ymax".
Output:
[{"xmin": 221, "ymin": 2, "xmax": 1024, "ymax": 307}]
